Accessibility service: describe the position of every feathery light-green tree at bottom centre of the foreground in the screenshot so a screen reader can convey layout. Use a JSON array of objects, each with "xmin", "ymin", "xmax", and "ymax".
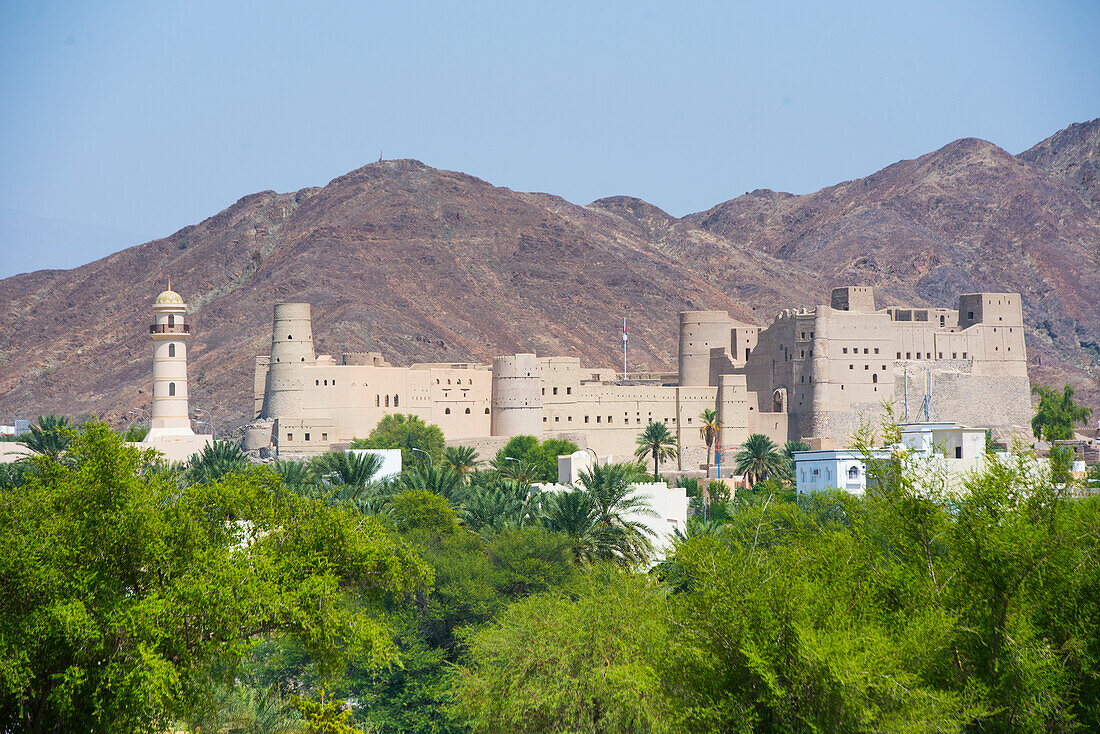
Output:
[{"xmin": 451, "ymin": 570, "xmax": 668, "ymax": 734}]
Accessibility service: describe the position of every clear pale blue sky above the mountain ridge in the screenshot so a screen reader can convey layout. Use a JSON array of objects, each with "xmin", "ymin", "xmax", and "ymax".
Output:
[{"xmin": 0, "ymin": 0, "xmax": 1100, "ymax": 276}]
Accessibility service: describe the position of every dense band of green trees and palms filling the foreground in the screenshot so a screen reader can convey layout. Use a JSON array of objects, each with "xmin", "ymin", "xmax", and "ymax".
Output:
[{"xmin": 0, "ymin": 415, "xmax": 1100, "ymax": 734}]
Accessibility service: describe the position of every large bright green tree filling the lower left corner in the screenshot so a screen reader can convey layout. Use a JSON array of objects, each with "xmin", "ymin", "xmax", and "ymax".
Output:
[{"xmin": 0, "ymin": 421, "xmax": 432, "ymax": 732}]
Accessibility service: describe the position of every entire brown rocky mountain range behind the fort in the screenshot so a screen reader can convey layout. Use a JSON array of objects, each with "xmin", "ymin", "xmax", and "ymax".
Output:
[{"xmin": 0, "ymin": 121, "xmax": 1100, "ymax": 429}]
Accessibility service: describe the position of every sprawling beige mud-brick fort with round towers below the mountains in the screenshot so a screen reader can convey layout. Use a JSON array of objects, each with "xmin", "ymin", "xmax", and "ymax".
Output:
[{"xmin": 245, "ymin": 287, "xmax": 1031, "ymax": 468}]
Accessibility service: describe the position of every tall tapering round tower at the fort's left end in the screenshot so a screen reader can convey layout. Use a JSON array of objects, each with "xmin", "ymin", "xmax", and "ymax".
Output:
[{"xmin": 262, "ymin": 304, "xmax": 316, "ymax": 418}]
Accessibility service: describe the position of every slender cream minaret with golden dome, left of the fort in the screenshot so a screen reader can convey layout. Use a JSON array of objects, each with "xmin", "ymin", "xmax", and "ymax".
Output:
[{"xmin": 145, "ymin": 278, "xmax": 195, "ymax": 441}]
